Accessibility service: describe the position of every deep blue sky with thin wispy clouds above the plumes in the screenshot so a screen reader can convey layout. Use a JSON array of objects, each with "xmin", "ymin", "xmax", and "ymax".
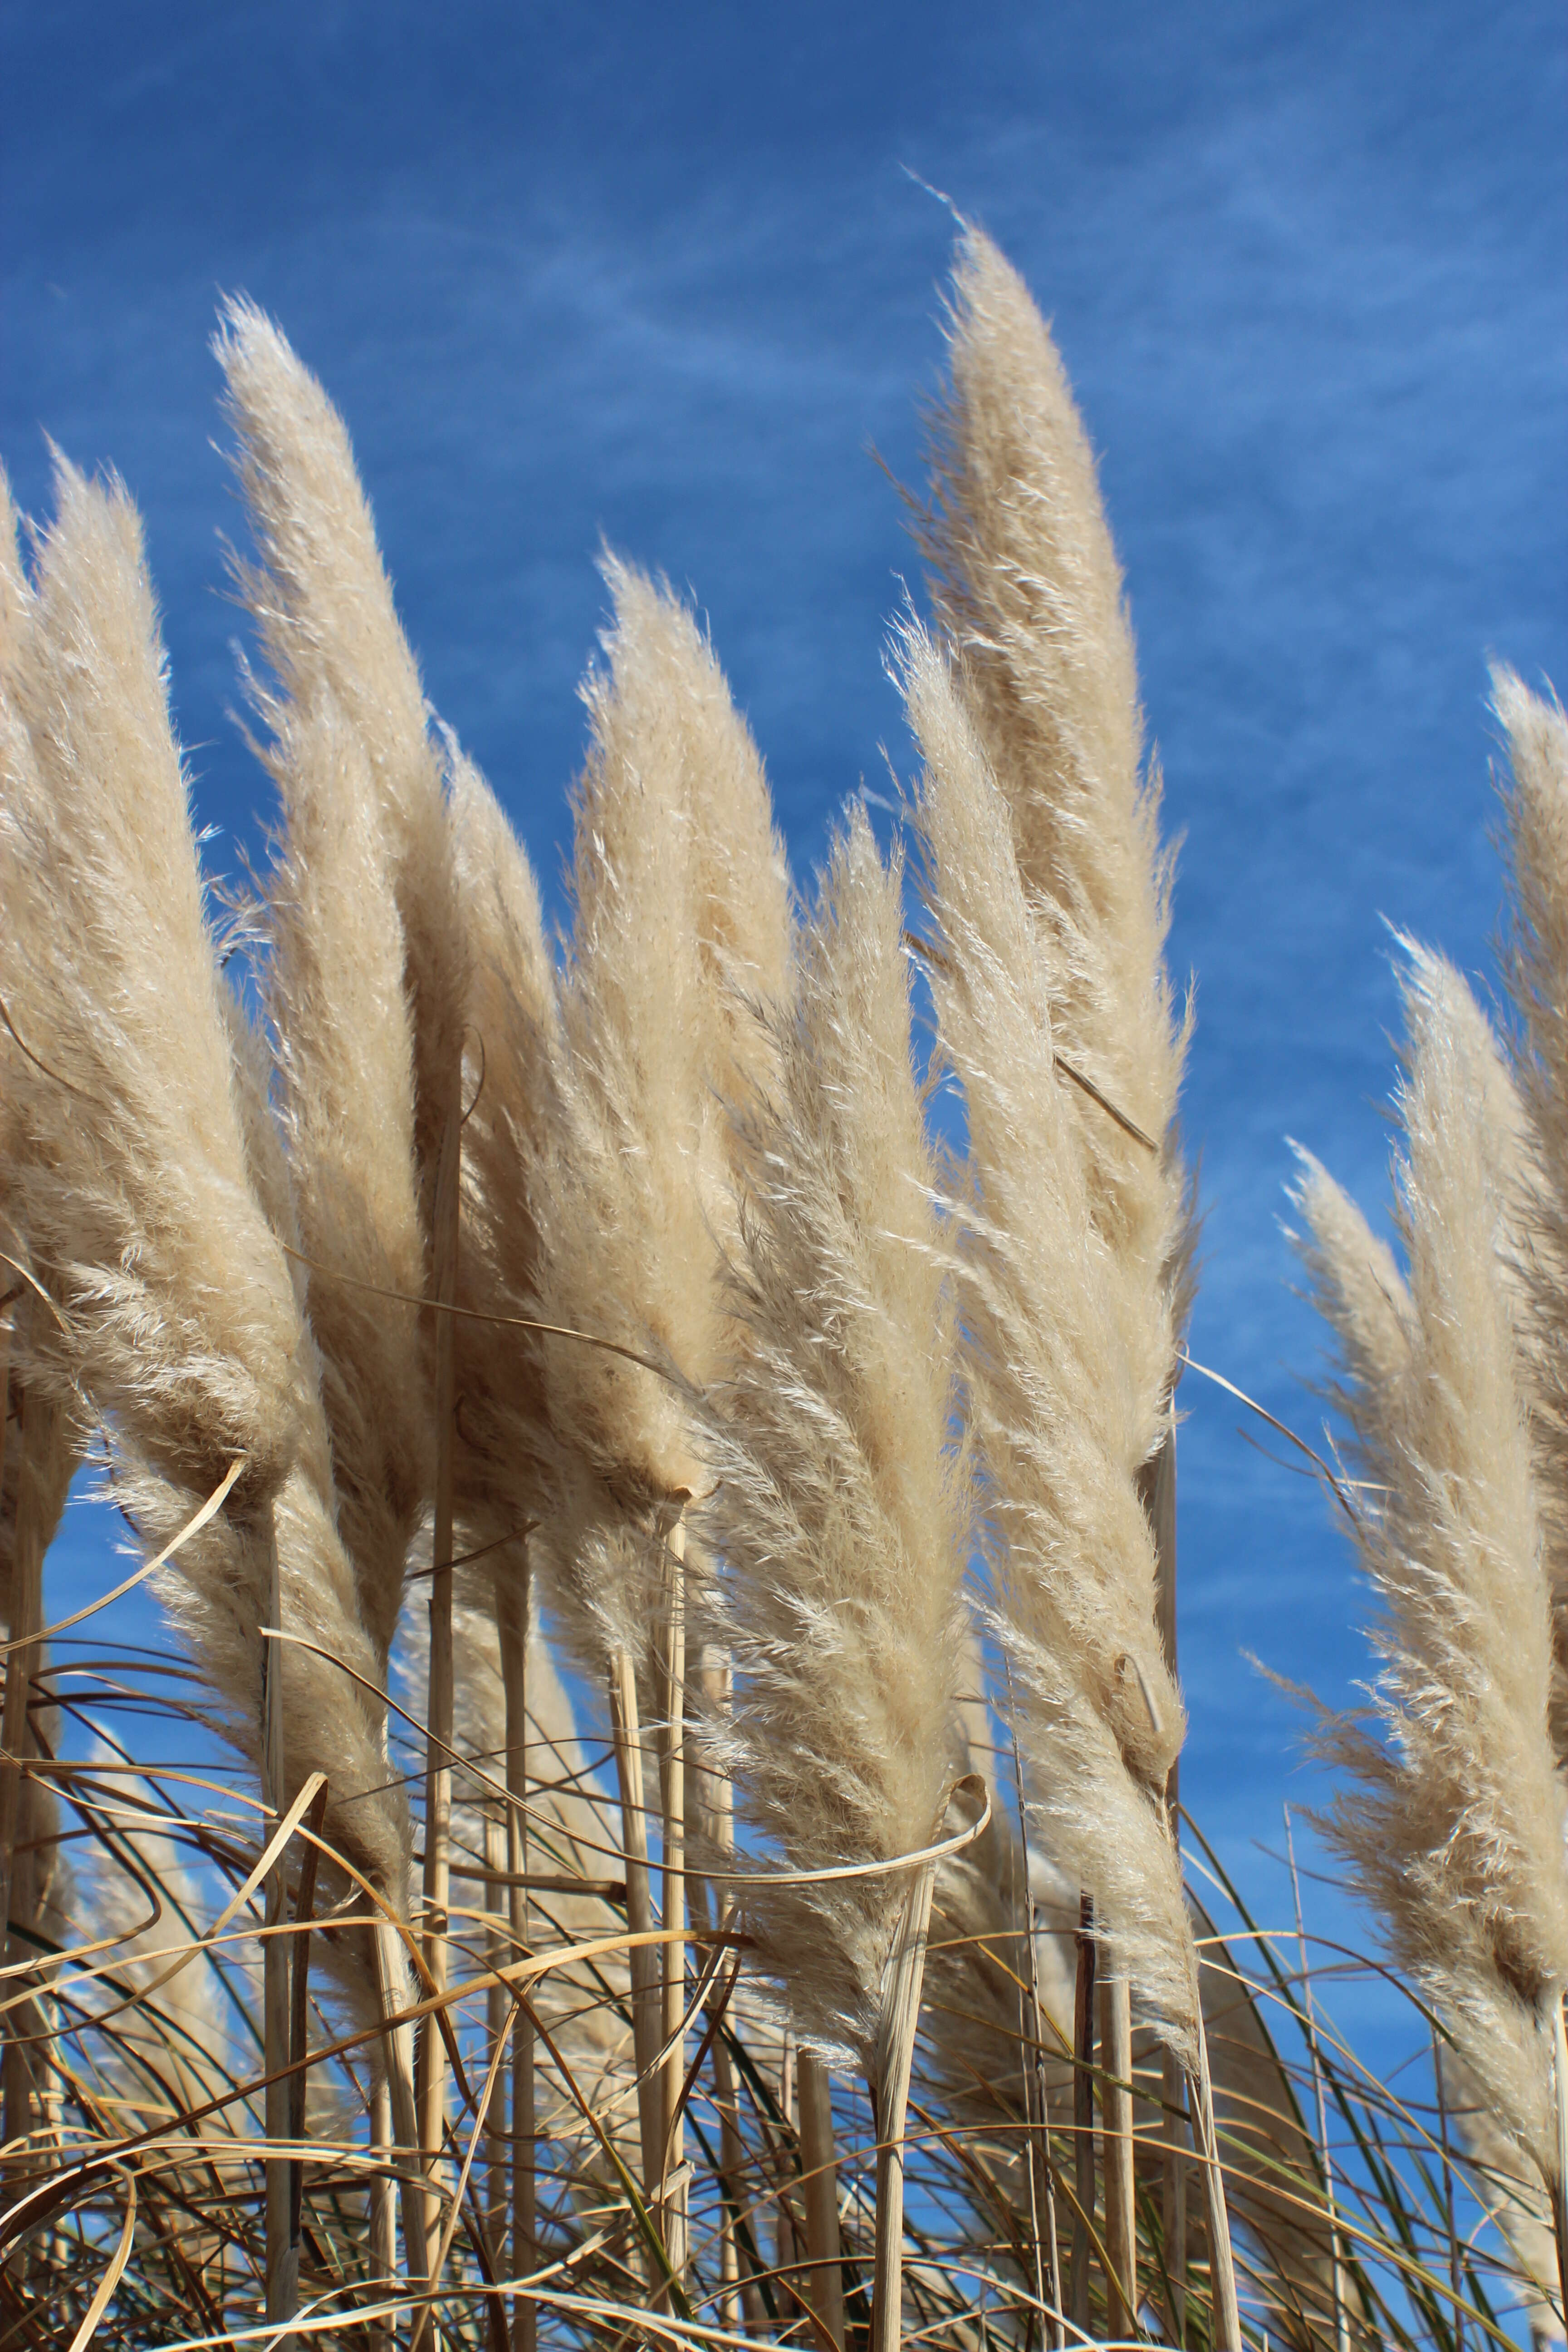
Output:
[{"xmin": 0, "ymin": 0, "xmax": 1568, "ymax": 2051}]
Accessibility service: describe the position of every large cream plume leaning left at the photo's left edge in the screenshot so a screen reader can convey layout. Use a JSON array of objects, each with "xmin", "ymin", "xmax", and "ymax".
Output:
[{"xmin": 0, "ymin": 449, "xmax": 407, "ymax": 1957}]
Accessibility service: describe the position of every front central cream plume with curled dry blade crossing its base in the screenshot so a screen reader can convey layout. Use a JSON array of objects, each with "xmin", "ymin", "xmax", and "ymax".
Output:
[{"xmin": 698, "ymin": 809, "xmax": 969, "ymax": 2063}]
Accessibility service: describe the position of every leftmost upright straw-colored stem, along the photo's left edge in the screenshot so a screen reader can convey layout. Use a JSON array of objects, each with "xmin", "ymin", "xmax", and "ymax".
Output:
[{"xmin": 0, "ymin": 1383, "xmax": 59, "ymax": 2204}]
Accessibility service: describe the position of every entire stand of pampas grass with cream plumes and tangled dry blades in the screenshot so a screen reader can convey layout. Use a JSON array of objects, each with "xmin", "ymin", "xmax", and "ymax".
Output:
[{"xmin": 0, "ymin": 230, "xmax": 1568, "ymax": 2352}]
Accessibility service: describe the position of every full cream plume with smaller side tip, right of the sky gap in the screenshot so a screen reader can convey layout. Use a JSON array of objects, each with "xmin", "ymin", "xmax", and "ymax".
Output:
[{"xmin": 1303, "ymin": 943, "xmax": 1568, "ymax": 2173}]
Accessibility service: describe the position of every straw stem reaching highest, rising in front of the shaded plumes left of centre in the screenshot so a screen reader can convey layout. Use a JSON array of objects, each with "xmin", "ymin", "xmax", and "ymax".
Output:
[{"xmin": 416, "ymin": 1112, "xmax": 463, "ymax": 2274}]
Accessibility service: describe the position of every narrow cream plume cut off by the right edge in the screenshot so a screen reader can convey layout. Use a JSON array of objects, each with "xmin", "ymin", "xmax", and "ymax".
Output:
[{"xmin": 1493, "ymin": 668, "xmax": 1568, "ymax": 1764}]
